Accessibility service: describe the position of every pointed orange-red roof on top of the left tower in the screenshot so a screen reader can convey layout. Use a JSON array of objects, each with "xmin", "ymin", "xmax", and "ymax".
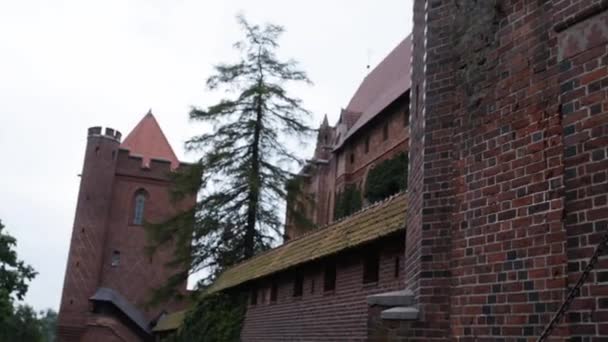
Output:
[{"xmin": 120, "ymin": 110, "xmax": 179, "ymax": 169}]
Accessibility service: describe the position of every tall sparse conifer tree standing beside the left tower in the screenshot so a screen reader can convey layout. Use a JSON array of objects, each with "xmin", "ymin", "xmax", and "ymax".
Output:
[{"xmin": 149, "ymin": 16, "xmax": 312, "ymax": 294}]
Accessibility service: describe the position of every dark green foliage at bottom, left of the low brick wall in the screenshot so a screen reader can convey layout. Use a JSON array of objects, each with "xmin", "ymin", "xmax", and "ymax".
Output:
[{"xmin": 168, "ymin": 293, "xmax": 247, "ymax": 342}]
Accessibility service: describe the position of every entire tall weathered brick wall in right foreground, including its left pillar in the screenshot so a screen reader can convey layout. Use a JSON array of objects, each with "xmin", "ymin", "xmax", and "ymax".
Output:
[{"xmin": 406, "ymin": 0, "xmax": 608, "ymax": 341}]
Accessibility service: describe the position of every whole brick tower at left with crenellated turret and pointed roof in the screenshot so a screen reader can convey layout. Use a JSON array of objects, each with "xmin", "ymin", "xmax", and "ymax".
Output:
[{"xmin": 58, "ymin": 113, "xmax": 194, "ymax": 342}]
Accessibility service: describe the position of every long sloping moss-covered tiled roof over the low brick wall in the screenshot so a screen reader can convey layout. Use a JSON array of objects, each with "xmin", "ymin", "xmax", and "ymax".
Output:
[{"xmin": 207, "ymin": 193, "xmax": 407, "ymax": 293}]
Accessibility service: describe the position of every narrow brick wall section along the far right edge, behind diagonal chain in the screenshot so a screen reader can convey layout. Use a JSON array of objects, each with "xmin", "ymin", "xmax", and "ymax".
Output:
[{"xmin": 554, "ymin": 5, "xmax": 608, "ymax": 341}]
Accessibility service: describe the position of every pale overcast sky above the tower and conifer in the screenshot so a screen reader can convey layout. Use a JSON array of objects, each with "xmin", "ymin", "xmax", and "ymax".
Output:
[{"xmin": 0, "ymin": 0, "xmax": 412, "ymax": 309}]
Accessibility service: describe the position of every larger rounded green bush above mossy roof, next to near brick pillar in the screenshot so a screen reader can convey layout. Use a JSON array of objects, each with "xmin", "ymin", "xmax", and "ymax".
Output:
[{"xmin": 365, "ymin": 153, "xmax": 408, "ymax": 203}]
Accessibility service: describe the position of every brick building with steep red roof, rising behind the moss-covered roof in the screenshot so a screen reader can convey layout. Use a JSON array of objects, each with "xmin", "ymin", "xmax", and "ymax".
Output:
[{"xmin": 285, "ymin": 37, "xmax": 412, "ymax": 239}]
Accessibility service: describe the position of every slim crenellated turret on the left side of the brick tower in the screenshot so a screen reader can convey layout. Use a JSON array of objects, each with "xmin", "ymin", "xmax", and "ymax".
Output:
[{"xmin": 58, "ymin": 127, "xmax": 120, "ymax": 337}]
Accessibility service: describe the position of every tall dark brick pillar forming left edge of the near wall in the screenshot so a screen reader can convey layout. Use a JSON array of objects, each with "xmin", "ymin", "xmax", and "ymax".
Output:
[{"xmin": 405, "ymin": 0, "xmax": 455, "ymax": 341}]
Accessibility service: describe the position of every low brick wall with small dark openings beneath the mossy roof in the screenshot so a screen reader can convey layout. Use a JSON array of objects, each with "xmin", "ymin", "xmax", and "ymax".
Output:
[{"xmin": 241, "ymin": 234, "xmax": 403, "ymax": 342}]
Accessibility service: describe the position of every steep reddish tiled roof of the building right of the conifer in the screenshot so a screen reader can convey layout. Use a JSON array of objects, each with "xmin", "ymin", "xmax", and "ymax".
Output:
[{"xmin": 335, "ymin": 35, "xmax": 412, "ymax": 149}]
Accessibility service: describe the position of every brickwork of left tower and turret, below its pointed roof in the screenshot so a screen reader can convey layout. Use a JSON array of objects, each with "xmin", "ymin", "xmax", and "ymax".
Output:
[{"xmin": 58, "ymin": 127, "xmax": 194, "ymax": 341}]
